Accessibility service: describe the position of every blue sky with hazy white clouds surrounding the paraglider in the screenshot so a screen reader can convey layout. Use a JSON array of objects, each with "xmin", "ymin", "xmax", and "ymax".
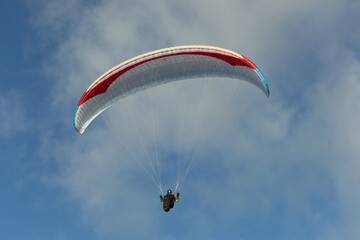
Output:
[{"xmin": 0, "ymin": 0, "xmax": 360, "ymax": 240}]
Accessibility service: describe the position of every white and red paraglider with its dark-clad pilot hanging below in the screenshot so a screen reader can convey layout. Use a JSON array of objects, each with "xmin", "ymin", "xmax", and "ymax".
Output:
[{"xmin": 73, "ymin": 45, "xmax": 270, "ymax": 212}]
